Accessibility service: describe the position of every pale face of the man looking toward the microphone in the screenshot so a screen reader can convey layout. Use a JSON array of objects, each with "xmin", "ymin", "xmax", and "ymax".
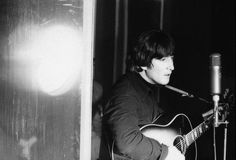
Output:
[{"xmin": 145, "ymin": 56, "xmax": 174, "ymax": 85}]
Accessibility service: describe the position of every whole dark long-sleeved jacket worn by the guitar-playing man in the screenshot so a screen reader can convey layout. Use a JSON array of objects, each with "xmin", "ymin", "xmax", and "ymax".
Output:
[{"xmin": 100, "ymin": 72, "xmax": 167, "ymax": 160}]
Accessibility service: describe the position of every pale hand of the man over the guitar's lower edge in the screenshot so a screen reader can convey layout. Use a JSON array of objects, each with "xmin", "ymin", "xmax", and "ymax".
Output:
[{"xmin": 165, "ymin": 146, "xmax": 185, "ymax": 160}]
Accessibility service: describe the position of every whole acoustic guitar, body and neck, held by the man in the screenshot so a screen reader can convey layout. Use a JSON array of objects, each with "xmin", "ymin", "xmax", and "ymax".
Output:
[{"xmin": 112, "ymin": 113, "xmax": 213, "ymax": 160}]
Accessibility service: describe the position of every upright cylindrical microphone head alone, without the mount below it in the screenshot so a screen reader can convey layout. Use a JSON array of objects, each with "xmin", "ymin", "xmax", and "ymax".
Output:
[{"xmin": 210, "ymin": 53, "xmax": 221, "ymax": 95}]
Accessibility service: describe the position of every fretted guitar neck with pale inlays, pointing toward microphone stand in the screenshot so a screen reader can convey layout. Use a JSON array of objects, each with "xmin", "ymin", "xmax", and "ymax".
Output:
[{"xmin": 185, "ymin": 117, "xmax": 212, "ymax": 147}]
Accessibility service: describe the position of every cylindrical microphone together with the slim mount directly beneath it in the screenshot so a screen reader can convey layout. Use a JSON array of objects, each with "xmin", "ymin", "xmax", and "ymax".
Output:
[{"xmin": 209, "ymin": 53, "xmax": 221, "ymax": 127}]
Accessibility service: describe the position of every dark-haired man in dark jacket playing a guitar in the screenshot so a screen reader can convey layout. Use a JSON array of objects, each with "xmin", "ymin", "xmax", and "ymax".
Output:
[{"xmin": 100, "ymin": 30, "xmax": 185, "ymax": 160}]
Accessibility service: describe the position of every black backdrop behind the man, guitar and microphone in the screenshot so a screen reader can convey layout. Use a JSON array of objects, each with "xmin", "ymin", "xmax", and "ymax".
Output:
[{"xmin": 94, "ymin": 0, "xmax": 235, "ymax": 160}]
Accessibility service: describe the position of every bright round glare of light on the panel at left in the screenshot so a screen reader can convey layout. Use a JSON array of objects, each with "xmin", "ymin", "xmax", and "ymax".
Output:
[{"xmin": 14, "ymin": 26, "xmax": 83, "ymax": 95}]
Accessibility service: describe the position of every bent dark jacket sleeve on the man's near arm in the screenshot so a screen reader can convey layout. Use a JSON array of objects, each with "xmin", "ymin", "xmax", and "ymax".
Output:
[{"xmin": 104, "ymin": 96, "xmax": 167, "ymax": 160}]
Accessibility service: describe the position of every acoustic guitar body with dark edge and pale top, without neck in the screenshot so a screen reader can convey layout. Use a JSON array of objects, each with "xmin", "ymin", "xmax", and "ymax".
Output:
[{"xmin": 140, "ymin": 114, "xmax": 196, "ymax": 160}]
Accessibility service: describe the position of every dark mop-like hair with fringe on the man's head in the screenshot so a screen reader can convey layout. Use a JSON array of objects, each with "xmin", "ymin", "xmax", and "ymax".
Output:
[{"xmin": 130, "ymin": 30, "xmax": 175, "ymax": 72}]
